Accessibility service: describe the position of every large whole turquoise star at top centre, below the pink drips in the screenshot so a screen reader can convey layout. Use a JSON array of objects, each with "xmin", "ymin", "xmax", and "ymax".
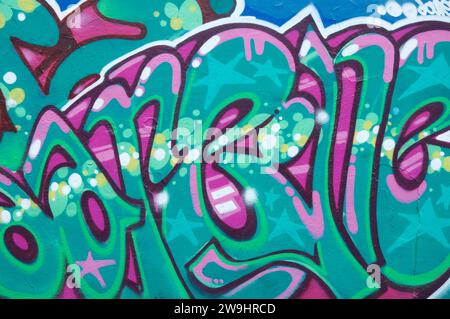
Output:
[{"xmin": 194, "ymin": 54, "xmax": 255, "ymax": 109}]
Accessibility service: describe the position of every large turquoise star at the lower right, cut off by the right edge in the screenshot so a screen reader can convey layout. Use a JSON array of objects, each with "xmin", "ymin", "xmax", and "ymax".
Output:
[{"xmin": 389, "ymin": 199, "xmax": 450, "ymax": 252}]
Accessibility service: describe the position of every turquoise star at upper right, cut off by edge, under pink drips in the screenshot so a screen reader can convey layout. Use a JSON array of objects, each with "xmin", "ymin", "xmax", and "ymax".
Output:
[{"xmin": 400, "ymin": 54, "xmax": 450, "ymax": 99}]
